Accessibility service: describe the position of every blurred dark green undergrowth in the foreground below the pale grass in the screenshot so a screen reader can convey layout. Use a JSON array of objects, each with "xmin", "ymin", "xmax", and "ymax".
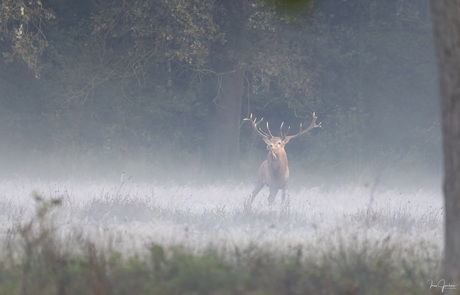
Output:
[{"xmin": 0, "ymin": 195, "xmax": 440, "ymax": 295}]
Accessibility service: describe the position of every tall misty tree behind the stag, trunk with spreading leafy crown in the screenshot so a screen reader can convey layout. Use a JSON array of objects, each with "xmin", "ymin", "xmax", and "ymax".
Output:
[{"xmin": 86, "ymin": 0, "xmax": 316, "ymax": 174}]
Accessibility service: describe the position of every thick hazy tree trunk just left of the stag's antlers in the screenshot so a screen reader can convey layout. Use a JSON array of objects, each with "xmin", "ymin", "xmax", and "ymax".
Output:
[{"xmin": 207, "ymin": 0, "xmax": 246, "ymax": 177}]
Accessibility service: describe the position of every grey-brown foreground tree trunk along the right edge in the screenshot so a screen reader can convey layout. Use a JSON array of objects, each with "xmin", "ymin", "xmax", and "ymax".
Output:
[{"xmin": 431, "ymin": 0, "xmax": 460, "ymax": 288}]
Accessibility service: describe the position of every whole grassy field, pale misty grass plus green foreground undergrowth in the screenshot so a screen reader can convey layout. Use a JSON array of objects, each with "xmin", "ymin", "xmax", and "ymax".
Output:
[{"xmin": 0, "ymin": 180, "xmax": 448, "ymax": 294}]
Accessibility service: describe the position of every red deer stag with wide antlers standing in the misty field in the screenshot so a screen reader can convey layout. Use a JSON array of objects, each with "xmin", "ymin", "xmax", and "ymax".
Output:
[{"xmin": 244, "ymin": 113, "xmax": 321, "ymax": 204}]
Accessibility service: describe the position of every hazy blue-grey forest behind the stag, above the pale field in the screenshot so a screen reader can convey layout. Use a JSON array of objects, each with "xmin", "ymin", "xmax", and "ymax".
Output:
[{"xmin": 0, "ymin": 0, "xmax": 441, "ymax": 185}]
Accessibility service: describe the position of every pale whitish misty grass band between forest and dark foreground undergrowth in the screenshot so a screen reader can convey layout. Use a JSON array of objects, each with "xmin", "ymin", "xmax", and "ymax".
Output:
[{"xmin": 0, "ymin": 181, "xmax": 444, "ymax": 255}]
